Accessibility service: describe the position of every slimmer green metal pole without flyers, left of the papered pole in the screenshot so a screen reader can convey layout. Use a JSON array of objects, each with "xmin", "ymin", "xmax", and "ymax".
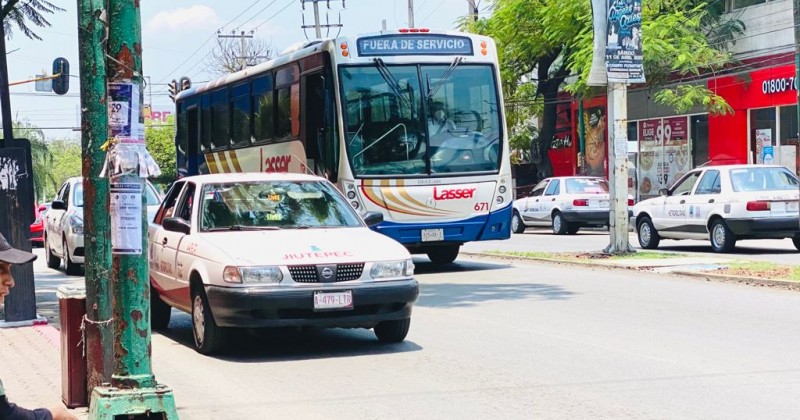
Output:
[{"xmin": 78, "ymin": 0, "xmax": 114, "ymax": 395}]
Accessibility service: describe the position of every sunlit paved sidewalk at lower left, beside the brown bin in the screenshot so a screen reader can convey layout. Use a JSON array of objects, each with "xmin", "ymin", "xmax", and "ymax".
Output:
[{"xmin": 0, "ymin": 324, "xmax": 87, "ymax": 418}]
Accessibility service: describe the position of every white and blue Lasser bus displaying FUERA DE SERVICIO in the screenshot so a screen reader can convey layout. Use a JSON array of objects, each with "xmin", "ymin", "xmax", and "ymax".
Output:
[{"xmin": 176, "ymin": 29, "xmax": 513, "ymax": 263}]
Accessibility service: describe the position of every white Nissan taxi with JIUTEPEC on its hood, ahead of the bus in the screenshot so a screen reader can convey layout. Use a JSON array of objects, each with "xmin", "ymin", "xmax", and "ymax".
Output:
[{"xmin": 148, "ymin": 173, "xmax": 419, "ymax": 354}]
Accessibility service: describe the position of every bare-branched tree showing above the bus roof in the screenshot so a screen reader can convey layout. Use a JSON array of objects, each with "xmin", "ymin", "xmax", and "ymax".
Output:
[{"xmin": 208, "ymin": 37, "xmax": 274, "ymax": 76}]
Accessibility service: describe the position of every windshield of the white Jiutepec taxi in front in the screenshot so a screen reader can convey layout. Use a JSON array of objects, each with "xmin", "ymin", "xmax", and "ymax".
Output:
[{"xmin": 200, "ymin": 181, "xmax": 363, "ymax": 231}]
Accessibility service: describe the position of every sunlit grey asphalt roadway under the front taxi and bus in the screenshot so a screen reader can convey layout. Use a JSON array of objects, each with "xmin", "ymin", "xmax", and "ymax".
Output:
[{"xmin": 23, "ymin": 248, "xmax": 800, "ymax": 420}]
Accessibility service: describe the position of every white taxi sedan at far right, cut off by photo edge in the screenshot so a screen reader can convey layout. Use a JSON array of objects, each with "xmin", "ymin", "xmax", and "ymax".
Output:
[{"xmin": 632, "ymin": 165, "xmax": 800, "ymax": 252}]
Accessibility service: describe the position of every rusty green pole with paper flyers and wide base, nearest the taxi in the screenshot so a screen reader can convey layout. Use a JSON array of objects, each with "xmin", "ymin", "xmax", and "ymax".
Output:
[{"xmin": 89, "ymin": 0, "xmax": 178, "ymax": 420}]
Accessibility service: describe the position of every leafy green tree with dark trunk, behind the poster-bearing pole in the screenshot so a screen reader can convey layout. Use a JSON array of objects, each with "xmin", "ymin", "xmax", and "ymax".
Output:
[{"xmin": 462, "ymin": 0, "xmax": 744, "ymax": 178}]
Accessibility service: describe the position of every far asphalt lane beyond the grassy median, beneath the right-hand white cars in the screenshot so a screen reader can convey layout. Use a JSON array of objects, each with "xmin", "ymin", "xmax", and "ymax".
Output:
[{"xmin": 461, "ymin": 228, "xmax": 800, "ymax": 265}]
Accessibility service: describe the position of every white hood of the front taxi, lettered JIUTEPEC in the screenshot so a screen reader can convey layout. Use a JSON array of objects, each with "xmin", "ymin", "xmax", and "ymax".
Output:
[{"xmin": 193, "ymin": 228, "xmax": 411, "ymax": 266}]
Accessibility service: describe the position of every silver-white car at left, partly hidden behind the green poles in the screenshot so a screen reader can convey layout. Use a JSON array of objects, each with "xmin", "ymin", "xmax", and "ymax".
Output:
[{"xmin": 43, "ymin": 177, "xmax": 161, "ymax": 275}]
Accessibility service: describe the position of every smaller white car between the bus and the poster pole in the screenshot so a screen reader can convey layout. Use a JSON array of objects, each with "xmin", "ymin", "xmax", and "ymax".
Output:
[{"xmin": 511, "ymin": 176, "xmax": 633, "ymax": 235}]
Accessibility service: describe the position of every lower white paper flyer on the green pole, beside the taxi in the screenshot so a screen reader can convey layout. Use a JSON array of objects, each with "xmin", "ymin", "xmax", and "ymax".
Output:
[{"xmin": 109, "ymin": 183, "xmax": 142, "ymax": 255}]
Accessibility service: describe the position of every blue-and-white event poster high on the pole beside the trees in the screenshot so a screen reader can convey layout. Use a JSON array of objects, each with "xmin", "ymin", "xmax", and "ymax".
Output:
[{"xmin": 606, "ymin": 0, "xmax": 645, "ymax": 83}]
